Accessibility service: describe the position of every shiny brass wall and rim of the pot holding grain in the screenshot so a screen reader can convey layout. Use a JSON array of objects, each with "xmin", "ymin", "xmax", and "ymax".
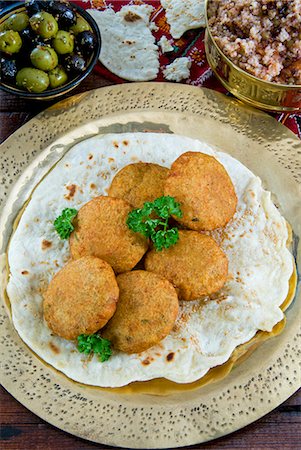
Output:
[{"xmin": 205, "ymin": 0, "xmax": 301, "ymax": 112}]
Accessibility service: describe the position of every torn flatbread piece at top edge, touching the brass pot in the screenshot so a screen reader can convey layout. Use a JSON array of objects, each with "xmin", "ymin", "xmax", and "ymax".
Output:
[{"xmin": 161, "ymin": 0, "xmax": 205, "ymax": 39}]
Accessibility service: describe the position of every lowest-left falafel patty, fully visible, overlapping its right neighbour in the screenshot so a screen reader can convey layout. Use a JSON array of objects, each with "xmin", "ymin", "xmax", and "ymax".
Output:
[{"xmin": 43, "ymin": 256, "xmax": 119, "ymax": 339}]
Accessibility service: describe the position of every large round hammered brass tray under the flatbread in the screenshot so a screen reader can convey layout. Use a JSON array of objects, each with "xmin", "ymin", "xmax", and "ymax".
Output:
[{"xmin": 0, "ymin": 83, "xmax": 301, "ymax": 448}]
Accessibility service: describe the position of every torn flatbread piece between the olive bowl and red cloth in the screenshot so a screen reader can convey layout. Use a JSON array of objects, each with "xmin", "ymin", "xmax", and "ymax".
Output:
[{"xmin": 88, "ymin": 5, "xmax": 159, "ymax": 81}]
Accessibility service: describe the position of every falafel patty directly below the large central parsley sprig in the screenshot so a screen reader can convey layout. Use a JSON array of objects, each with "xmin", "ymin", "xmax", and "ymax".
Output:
[{"xmin": 145, "ymin": 230, "xmax": 228, "ymax": 300}]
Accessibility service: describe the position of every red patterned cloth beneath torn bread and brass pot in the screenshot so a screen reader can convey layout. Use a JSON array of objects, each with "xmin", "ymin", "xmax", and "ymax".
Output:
[{"xmin": 74, "ymin": 0, "xmax": 301, "ymax": 139}]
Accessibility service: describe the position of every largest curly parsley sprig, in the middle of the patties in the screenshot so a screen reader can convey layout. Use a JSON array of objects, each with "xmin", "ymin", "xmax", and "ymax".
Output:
[{"xmin": 126, "ymin": 196, "xmax": 182, "ymax": 251}]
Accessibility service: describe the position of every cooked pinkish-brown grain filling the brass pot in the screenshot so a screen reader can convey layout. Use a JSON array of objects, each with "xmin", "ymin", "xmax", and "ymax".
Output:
[{"xmin": 208, "ymin": 0, "xmax": 301, "ymax": 85}]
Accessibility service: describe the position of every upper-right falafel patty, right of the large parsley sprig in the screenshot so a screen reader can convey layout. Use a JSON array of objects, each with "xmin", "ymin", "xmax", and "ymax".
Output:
[{"xmin": 164, "ymin": 152, "xmax": 237, "ymax": 231}]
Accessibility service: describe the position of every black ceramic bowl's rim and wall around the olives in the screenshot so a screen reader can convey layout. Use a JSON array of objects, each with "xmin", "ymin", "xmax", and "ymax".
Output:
[{"xmin": 0, "ymin": 2, "xmax": 101, "ymax": 100}]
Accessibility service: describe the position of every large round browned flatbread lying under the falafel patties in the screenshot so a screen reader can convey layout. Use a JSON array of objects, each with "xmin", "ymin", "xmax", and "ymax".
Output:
[{"xmin": 7, "ymin": 133, "xmax": 294, "ymax": 387}]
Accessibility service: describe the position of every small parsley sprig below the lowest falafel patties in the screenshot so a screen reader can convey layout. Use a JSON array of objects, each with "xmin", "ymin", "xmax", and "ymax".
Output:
[{"xmin": 77, "ymin": 334, "xmax": 112, "ymax": 362}]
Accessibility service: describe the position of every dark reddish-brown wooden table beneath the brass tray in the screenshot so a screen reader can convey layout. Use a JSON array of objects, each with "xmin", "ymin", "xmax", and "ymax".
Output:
[{"xmin": 0, "ymin": 74, "xmax": 301, "ymax": 450}]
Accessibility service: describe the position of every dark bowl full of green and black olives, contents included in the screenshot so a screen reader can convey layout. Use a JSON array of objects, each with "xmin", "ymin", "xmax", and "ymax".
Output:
[{"xmin": 0, "ymin": 0, "xmax": 101, "ymax": 100}]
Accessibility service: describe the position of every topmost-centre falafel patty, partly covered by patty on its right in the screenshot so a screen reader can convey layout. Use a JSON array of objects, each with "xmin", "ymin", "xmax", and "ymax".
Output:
[{"xmin": 108, "ymin": 162, "xmax": 169, "ymax": 208}]
